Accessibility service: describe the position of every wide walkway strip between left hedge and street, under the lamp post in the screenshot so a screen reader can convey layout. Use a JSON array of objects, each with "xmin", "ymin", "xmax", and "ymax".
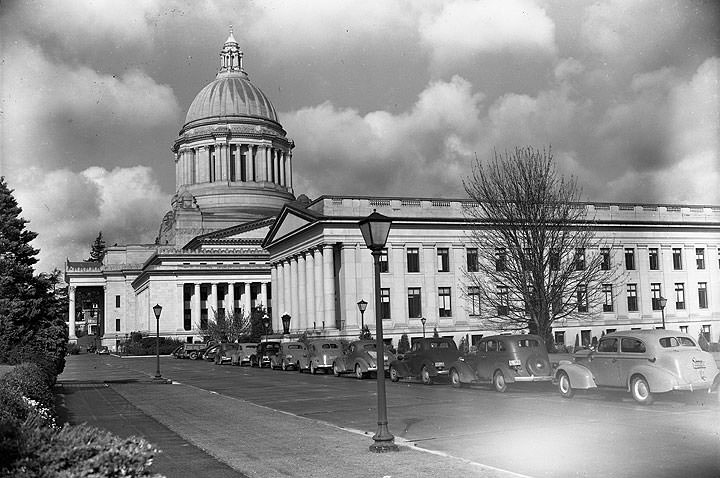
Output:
[{"xmin": 58, "ymin": 355, "xmax": 518, "ymax": 478}]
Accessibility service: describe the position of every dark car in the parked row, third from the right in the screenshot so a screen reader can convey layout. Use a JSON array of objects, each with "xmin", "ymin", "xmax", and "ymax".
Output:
[{"xmin": 390, "ymin": 338, "xmax": 461, "ymax": 385}]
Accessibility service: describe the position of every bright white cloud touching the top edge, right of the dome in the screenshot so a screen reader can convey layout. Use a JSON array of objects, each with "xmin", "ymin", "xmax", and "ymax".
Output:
[{"xmin": 420, "ymin": 0, "xmax": 556, "ymax": 65}]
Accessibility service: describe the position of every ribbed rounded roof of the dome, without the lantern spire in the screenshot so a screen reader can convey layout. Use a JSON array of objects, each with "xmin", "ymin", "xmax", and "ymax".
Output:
[{"xmin": 185, "ymin": 72, "xmax": 277, "ymax": 125}]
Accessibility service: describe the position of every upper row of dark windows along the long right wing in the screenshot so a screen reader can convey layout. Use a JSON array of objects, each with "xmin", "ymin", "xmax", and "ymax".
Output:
[{"xmin": 380, "ymin": 247, "xmax": 720, "ymax": 273}]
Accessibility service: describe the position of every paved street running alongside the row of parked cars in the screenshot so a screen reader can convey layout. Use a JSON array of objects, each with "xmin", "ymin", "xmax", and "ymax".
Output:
[{"xmin": 76, "ymin": 357, "xmax": 720, "ymax": 477}]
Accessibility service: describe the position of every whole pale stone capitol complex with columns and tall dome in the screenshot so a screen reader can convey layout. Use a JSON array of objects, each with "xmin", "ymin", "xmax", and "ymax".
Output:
[{"xmin": 65, "ymin": 32, "xmax": 720, "ymax": 350}]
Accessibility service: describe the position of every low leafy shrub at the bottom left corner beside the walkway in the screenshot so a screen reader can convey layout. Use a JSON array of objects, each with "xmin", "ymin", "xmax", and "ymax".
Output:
[{"xmin": 12, "ymin": 424, "xmax": 159, "ymax": 478}]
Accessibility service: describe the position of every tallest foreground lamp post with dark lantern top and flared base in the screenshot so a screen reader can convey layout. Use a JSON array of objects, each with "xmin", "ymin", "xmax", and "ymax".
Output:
[{"xmin": 358, "ymin": 211, "xmax": 398, "ymax": 453}]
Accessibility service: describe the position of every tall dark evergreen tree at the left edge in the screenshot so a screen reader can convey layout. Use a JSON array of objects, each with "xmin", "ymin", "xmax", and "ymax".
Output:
[{"xmin": 0, "ymin": 177, "xmax": 67, "ymax": 375}]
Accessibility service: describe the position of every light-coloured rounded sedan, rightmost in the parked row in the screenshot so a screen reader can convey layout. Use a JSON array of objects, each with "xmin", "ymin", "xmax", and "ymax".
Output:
[{"xmin": 555, "ymin": 330, "xmax": 720, "ymax": 405}]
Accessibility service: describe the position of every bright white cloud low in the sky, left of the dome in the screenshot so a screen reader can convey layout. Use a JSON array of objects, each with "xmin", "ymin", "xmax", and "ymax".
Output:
[{"xmin": 9, "ymin": 166, "xmax": 169, "ymax": 271}]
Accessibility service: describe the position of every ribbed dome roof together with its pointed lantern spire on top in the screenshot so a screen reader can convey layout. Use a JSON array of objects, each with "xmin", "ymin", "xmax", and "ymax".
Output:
[{"xmin": 184, "ymin": 33, "xmax": 278, "ymax": 128}]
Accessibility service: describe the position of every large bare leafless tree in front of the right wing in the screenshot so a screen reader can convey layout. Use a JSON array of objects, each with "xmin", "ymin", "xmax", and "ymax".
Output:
[{"xmin": 463, "ymin": 147, "xmax": 618, "ymax": 346}]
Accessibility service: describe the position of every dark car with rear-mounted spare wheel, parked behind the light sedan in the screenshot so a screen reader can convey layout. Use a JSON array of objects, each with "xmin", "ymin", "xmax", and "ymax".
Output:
[{"xmin": 450, "ymin": 334, "xmax": 553, "ymax": 392}]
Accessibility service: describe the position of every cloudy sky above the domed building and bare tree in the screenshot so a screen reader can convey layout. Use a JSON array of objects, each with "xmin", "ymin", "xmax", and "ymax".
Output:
[{"xmin": 0, "ymin": 0, "xmax": 720, "ymax": 270}]
